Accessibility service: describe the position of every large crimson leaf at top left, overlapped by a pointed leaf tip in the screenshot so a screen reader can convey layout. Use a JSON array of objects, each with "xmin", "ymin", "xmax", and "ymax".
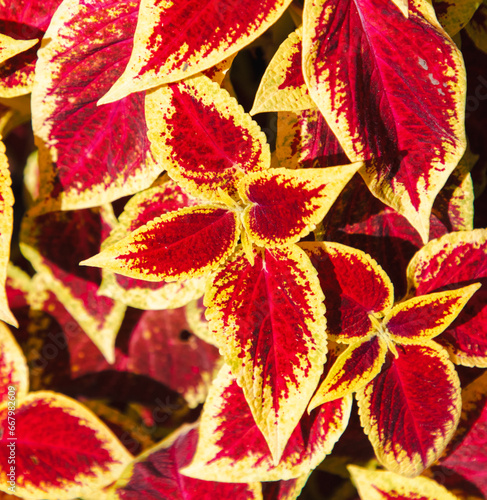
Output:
[{"xmin": 32, "ymin": 0, "xmax": 163, "ymax": 210}]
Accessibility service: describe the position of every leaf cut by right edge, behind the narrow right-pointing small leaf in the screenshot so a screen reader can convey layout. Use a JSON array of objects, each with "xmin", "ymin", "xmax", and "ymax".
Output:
[{"xmin": 408, "ymin": 229, "xmax": 487, "ymax": 367}]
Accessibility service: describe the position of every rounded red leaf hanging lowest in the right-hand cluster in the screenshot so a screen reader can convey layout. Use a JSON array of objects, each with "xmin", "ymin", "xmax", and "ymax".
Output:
[{"xmin": 357, "ymin": 341, "xmax": 461, "ymax": 477}]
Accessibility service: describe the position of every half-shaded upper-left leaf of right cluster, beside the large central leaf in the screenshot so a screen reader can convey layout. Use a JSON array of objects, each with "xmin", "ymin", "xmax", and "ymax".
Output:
[{"xmin": 300, "ymin": 242, "xmax": 394, "ymax": 344}]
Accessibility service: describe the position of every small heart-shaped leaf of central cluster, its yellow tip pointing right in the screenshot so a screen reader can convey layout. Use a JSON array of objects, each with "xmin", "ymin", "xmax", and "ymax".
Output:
[{"xmin": 238, "ymin": 163, "xmax": 362, "ymax": 248}]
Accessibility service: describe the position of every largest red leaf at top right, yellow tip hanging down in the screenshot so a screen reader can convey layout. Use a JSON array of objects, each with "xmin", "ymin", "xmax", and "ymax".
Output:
[{"xmin": 303, "ymin": 0, "xmax": 466, "ymax": 242}]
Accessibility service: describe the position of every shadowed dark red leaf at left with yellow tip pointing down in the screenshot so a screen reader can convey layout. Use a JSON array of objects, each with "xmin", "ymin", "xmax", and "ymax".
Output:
[{"xmin": 21, "ymin": 205, "xmax": 125, "ymax": 362}]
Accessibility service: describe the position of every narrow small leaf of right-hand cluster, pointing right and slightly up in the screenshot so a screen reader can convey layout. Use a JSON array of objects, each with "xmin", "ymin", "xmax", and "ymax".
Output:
[{"xmin": 382, "ymin": 283, "xmax": 481, "ymax": 344}]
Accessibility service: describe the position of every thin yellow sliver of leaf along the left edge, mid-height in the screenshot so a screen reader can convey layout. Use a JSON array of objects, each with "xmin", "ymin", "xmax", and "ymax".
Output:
[{"xmin": 0, "ymin": 137, "xmax": 19, "ymax": 327}]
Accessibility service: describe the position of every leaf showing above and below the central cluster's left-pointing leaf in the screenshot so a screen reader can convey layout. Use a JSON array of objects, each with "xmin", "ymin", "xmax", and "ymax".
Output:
[{"xmin": 99, "ymin": 181, "xmax": 205, "ymax": 310}]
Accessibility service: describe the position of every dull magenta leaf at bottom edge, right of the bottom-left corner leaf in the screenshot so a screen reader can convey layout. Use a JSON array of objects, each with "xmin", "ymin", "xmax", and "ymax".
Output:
[{"xmin": 110, "ymin": 425, "xmax": 262, "ymax": 500}]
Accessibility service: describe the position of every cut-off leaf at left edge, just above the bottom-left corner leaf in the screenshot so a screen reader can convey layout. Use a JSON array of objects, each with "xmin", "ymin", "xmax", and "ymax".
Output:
[{"xmin": 0, "ymin": 322, "xmax": 29, "ymax": 404}]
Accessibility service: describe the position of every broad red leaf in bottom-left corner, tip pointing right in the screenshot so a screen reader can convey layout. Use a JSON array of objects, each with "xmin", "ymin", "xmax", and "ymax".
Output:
[{"xmin": 0, "ymin": 391, "xmax": 132, "ymax": 500}]
